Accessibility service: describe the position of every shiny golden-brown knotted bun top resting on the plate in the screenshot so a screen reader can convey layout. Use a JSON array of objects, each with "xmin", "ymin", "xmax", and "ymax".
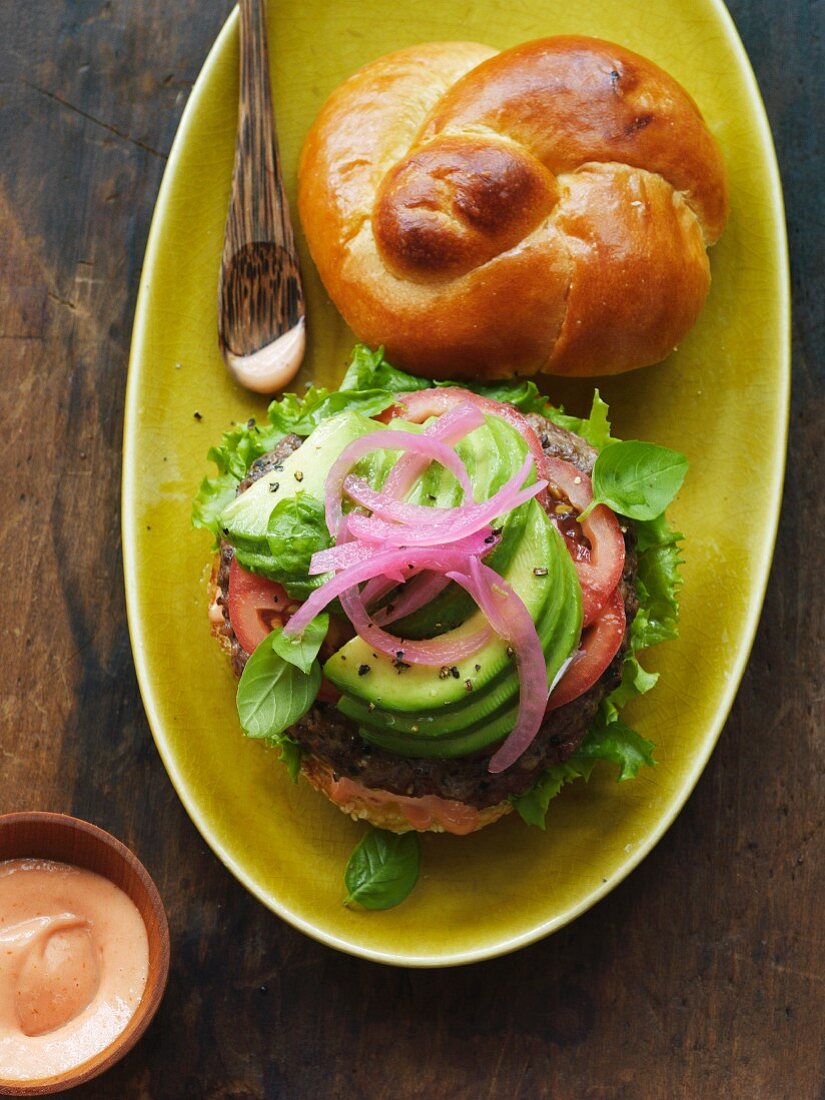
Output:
[{"xmin": 299, "ymin": 37, "xmax": 727, "ymax": 377}]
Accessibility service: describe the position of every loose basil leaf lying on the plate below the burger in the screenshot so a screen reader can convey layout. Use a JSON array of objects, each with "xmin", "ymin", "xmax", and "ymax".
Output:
[{"xmin": 344, "ymin": 828, "xmax": 421, "ymax": 909}]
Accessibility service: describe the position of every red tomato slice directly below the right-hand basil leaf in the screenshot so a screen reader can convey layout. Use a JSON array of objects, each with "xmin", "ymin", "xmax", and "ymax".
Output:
[{"xmin": 545, "ymin": 457, "xmax": 625, "ymax": 626}]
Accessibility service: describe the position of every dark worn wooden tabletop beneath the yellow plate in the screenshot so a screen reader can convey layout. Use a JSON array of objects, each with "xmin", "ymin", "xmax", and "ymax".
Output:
[{"xmin": 0, "ymin": 0, "xmax": 825, "ymax": 1100}]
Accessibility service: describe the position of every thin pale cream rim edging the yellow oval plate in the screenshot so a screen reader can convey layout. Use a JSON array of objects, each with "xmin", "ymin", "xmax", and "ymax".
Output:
[{"xmin": 121, "ymin": 0, "xmax": 791, "ymax": 968}]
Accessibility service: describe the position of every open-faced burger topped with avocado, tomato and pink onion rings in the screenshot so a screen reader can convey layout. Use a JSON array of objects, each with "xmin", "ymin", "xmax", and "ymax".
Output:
[{"xmin": 193, "ymin": 345, "xmax": 686, "ymax": 835}]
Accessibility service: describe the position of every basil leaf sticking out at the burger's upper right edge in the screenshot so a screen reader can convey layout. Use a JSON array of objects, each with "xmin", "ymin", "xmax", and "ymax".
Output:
[{"xmin": 580, "ymin": 439, "xmax": 688, "ymax": 520}]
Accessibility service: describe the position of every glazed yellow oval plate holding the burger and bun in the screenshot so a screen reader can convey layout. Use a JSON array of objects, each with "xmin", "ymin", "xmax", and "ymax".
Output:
[{"xmin": 123, "ymin": 0, "xmax": 790, "ymax": 966}]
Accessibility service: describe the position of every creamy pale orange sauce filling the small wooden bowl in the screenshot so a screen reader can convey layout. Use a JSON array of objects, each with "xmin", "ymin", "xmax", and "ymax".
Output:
[{"xmin": 0, "ymin": 859, "xmax": 149, "ymax": 1081}]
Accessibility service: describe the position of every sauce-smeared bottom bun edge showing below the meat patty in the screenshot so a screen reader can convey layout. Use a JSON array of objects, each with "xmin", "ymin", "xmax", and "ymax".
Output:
[{"xmin": 300, "ymin": 756, "xmax": 513, "ymax": 836}]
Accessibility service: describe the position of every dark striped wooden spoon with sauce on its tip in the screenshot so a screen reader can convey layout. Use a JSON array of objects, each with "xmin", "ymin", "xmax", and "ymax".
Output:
[{"xmin": 218, "ymin": 0, "xmax": 306, "ymax": 394}]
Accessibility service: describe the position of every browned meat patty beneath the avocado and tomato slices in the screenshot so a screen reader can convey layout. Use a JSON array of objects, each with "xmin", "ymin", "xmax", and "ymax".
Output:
[{"xmin": 217, "ymin": 414, "xmax": 638, "ymax": 810}]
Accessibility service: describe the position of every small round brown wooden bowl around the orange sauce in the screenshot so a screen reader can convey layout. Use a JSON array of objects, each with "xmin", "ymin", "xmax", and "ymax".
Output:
[{"xmin": 0, "ymin": 813, "xmax": 169, "ymax": 1097}]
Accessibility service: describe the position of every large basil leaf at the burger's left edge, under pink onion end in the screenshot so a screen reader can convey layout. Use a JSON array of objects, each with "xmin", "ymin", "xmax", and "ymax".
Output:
[{"xmin": 237, "ymin": 635, "xmax": 321, "ymax": 739}]
